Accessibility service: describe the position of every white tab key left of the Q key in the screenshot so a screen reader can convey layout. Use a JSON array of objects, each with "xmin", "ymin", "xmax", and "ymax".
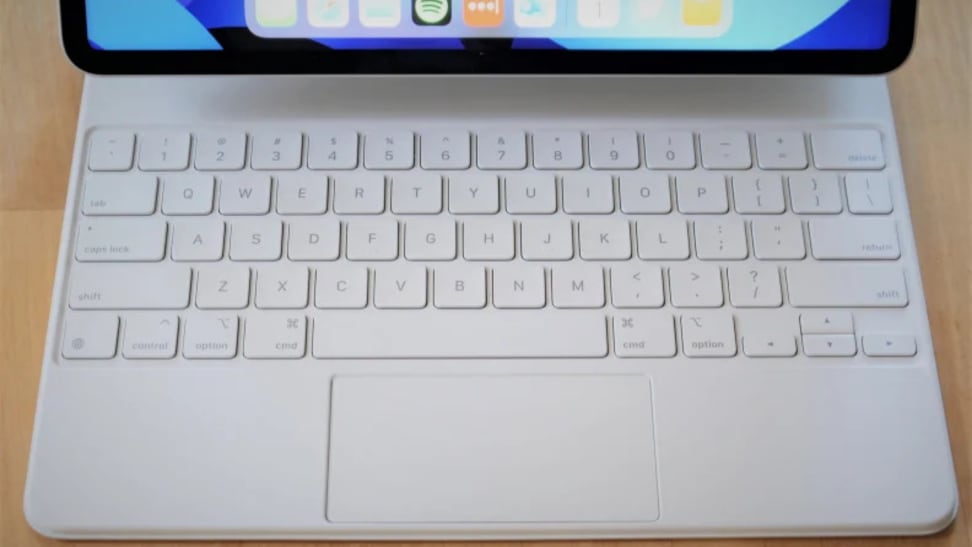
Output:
[{"xmin": 81, "ymin": 174, "xmax": 158, "ymax": 216}]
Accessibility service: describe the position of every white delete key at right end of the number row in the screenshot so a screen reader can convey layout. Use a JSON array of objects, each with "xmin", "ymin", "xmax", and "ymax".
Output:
[{"xmin": 810, "ymin": 129, "xmax": 886, "ymax": 170}]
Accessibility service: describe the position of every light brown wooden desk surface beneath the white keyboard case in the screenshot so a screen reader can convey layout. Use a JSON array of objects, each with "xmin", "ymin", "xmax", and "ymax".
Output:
[{"xmin": 0, "ymin": 0, "xmax": 972, "ymax": 547}]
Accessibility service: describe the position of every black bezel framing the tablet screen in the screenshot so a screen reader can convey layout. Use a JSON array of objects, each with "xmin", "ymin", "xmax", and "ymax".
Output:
[{"xmin": 60, "ymin": 0, "xmax": 918, "ymax": 74}]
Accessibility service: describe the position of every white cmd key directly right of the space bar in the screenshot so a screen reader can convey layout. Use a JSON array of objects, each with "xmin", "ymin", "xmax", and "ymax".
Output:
[{"xmin": 613, "ymin": 312, "xmax": 677, "ymax": 358}]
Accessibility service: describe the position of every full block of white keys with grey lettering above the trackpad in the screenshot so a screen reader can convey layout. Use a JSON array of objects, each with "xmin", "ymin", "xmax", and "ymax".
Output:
[{"xmin": 60, "ymin": 128, "xmax": 919, "ymax": 363}]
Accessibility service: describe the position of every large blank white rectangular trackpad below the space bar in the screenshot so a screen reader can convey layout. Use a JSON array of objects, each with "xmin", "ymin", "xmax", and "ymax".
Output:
[{"xmin": 327, "ymin": 376, "xmax": 658, "ymax": 523}]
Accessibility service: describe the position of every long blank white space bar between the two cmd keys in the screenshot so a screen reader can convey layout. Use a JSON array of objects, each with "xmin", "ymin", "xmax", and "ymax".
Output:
[{"xmin": 313, "ymin": 310, "xmax": 608, "ymax": 359}]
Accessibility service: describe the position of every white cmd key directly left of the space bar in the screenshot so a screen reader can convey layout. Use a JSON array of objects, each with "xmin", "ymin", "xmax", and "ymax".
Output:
[{"xmin": 243, "ymin": 313, "xmax": 307, "ymax": 359}]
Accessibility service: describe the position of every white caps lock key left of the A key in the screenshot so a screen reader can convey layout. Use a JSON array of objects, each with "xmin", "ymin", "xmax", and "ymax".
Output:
[{"xmin": 74, "ymin": 218, "xmax": 167, "ymax": 262}]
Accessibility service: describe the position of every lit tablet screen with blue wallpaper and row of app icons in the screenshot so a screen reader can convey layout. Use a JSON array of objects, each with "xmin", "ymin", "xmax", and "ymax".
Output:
[{"xmin": 85, "ymin": 0, "xmax": 892, "ymax": 52}]
